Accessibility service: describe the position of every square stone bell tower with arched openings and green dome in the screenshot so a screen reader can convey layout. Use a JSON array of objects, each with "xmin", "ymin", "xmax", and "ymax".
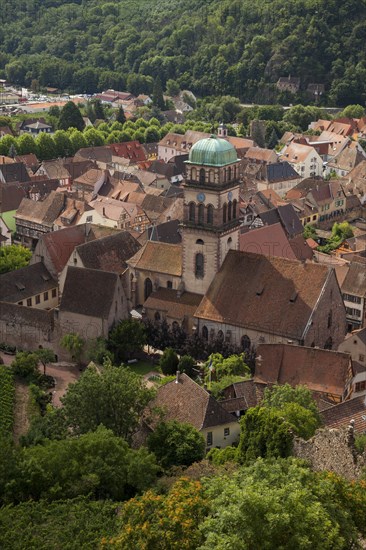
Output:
[{"xmin": 182, "ymin": 135, "xmax": 241, "ymax": 294}]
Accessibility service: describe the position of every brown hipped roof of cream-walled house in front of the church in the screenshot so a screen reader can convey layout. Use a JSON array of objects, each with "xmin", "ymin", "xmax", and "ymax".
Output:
[{"xmin": 150, "ymin": 374, "xmax": 236, "ymax": 430}]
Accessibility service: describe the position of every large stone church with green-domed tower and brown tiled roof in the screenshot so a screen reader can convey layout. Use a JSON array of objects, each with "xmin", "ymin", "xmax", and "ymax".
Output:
[{"xmin": 127, "ymin": 131, "xmax": 346, "ymax": 349}]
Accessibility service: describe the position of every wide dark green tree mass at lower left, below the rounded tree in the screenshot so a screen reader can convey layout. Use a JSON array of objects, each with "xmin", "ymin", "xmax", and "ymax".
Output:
[{"xmin": 13, "ymin": 426, "xmax": 158, "ymax": 501}]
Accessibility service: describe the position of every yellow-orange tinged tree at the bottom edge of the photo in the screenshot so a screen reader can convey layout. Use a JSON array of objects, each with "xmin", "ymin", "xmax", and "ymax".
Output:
[{"xmin": 109, "ymin": 478, "xmax": 209, "ymax": 550}]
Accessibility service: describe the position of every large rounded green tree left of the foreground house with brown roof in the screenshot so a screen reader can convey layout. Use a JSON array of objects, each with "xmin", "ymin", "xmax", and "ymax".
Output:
[{"xmin": 62, "ymin": 363, "xmax": 154, "ymax": 440}]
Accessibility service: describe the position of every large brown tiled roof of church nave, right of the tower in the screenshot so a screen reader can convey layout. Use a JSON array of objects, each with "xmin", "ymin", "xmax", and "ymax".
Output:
[{"xmin": 196, "ymin": 250, "xmax": 329, "ymax": 339}]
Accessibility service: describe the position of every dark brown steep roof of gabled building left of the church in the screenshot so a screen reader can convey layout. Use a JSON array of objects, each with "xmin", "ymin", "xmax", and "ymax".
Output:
[{"xmin": 60, "ymin": 266, "xmax": 118, "ymax": 319}]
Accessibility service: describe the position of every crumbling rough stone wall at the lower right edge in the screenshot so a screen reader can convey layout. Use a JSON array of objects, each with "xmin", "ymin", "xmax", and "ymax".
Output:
[{"xmin": 294, "ymin": 424, "xmax": 366, "ymax": 480}]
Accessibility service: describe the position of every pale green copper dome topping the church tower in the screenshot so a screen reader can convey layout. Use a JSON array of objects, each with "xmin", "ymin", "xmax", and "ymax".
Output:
[{"xmin": 187, "ymin": 135, "xmax": 239, "ymax": 166}]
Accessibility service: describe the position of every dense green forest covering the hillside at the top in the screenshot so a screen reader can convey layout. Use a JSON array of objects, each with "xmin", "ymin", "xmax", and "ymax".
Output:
[{"xmin": 0, "ymin": 0, "xmax": 366, "ymax": 106}]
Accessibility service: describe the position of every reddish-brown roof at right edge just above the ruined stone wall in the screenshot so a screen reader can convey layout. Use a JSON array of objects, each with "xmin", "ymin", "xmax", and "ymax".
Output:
[{"xmin": 321, "ymin": 395, "xmax": 366, "ymax": 433}]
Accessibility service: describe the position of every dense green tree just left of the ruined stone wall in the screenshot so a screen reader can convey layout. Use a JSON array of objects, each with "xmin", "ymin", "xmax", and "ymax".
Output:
[{"xmin": 238, "ymin": 407, "xmax": 293, "ymax": 464}]
